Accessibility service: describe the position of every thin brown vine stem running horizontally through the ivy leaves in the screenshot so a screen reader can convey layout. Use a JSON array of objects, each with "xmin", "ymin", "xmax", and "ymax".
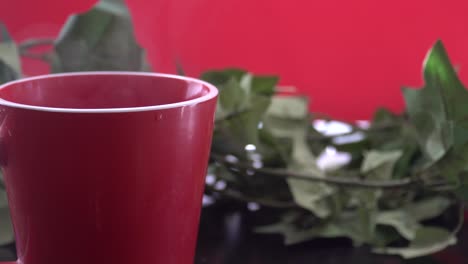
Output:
[{"xmin": 211, "ymin": 153, "xmax": 419, "ymax": 189}]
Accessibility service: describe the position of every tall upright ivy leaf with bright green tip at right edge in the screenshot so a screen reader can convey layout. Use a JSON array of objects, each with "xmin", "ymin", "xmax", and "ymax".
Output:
[{"xmin": 403, "ymin": 41, "xmax": 468, "ymax": 164}]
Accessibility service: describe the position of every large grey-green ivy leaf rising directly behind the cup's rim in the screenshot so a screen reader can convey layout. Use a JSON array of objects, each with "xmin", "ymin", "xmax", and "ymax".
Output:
[{"xmin": 52, "ymin": 1, "xmax": 151, "ymax": 72}]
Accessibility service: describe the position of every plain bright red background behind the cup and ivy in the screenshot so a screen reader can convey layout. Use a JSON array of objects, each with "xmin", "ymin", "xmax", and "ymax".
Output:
[{"xmin": 0, "ymin": 0, "xmax": 468, "ymax": 119}]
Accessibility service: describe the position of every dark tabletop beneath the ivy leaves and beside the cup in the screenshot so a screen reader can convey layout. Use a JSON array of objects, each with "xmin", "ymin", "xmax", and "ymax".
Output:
[{"xmin": 0, "ymin": 206, "xmax": 468, "ymax": 264}]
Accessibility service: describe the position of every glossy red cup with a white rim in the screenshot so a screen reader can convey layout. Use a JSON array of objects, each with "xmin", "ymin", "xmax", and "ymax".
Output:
[{"xmin": 0, "ymin": 72, "xmax": 217, "ymax": 264}]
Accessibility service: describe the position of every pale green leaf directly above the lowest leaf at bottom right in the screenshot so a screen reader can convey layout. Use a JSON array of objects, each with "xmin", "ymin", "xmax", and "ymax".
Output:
[{"xmin": 376, "ymin": 196, "xmax": 451, "ymax": 241}]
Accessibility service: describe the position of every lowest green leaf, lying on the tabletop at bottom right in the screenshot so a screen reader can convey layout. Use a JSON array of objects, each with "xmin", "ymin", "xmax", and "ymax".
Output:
[{"xmin": 373, "ymin": 227, "xmax": 457, "ymax": 259}]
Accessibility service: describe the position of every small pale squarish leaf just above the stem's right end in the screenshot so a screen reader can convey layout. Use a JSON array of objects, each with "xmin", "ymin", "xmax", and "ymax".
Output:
[{"xmin": 361, "ymin": 150, "xmax": 403, "ymax": 180}]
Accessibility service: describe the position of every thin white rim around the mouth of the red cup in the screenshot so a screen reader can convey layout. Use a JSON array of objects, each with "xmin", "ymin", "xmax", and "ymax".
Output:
[{"xmin": 0, "ymin": 71, "xmax": 218, "ymax": 113}]
